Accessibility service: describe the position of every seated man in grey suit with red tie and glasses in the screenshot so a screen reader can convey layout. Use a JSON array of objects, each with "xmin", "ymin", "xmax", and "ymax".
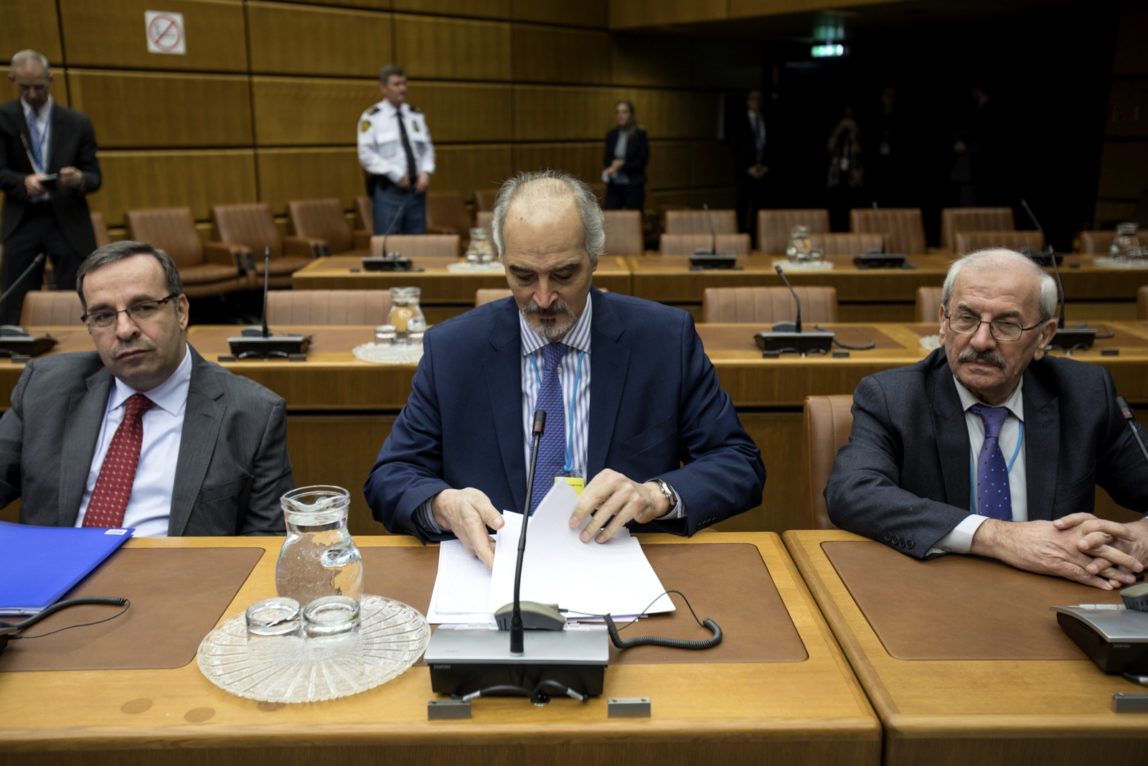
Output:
[{"xmin": 0, "ymin": 241, "xmax": 293, "ymax": 536}]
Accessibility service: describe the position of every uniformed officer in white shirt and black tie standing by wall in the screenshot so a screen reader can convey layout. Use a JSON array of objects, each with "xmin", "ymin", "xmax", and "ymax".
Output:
[{"xmin": 358, "ymin": 64, "xmax": 434, "ymax": 234}]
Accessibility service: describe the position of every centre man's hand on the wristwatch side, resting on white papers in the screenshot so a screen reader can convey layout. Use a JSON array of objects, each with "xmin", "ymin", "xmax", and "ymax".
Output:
[{"xmin": 571, "ymin": 469, "xmax": 670, "ymax": 542}]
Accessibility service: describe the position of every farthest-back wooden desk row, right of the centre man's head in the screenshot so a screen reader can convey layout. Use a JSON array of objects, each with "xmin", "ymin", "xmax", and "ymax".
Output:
[{"xmin": 626, "ymin": 254, "xmax": 1148, "ymax": 322}]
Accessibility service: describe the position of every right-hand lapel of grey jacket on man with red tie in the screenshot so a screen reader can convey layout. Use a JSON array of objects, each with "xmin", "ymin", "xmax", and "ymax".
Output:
[{"xmin": 168, "ymin": 347, "xmax": 227, "ymax": 537}]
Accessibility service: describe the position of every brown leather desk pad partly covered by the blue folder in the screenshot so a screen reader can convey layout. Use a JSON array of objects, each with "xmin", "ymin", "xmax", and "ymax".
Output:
[{"xmin": 0, "ymin": 548, "xmax": 263, "ymax": 671}]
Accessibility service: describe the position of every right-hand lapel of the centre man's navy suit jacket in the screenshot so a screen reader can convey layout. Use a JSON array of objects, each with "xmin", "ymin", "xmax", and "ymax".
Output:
[{"xmin": 585, "ymin": 289, "xmax": 630, "ymax": 480}]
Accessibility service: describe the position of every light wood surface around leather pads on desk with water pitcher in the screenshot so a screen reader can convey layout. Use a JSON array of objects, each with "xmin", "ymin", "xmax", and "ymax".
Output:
[{"xmin": 0, "ymin": 532, "xmax": 881, "ymax": 766}]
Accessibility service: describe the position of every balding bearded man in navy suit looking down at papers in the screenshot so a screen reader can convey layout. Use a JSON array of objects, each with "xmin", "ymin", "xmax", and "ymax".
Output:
[{"xmin": 364, "ymin": 171, "xmax": 765, "ymax": 565}]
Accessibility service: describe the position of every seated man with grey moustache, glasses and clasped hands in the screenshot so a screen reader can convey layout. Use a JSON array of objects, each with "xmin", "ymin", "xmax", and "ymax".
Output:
[{"xmin": 825, "ymin": 250, "xmax": 1148, "ymax": 589}]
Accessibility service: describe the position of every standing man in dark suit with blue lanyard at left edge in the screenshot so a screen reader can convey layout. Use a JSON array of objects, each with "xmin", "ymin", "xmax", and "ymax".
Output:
[{"xmin": 0, "ymin": 51, "xmax": 101, "ymax": 324}]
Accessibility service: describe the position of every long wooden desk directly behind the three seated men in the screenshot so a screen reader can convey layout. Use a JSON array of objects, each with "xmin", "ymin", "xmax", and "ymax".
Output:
[{"xmin": 0, "ymin": 322, "xmax": 1148, "ymax": 534}]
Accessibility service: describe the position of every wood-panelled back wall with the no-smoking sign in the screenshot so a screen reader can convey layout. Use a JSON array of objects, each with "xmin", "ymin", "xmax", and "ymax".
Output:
[{"xmin": 0, "ymin": 0, "xmax": 761, "ymax": 234}]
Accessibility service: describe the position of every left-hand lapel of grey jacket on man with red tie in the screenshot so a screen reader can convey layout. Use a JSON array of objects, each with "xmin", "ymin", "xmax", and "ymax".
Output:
[{"xmin": 56, "ymin": 363, "xmax": 111, "ymax": 527}]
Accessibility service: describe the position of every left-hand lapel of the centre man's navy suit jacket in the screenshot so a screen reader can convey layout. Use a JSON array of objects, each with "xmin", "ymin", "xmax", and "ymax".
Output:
[{"xmin": 482, "ymin": 300, "xmax": 526, "ymax": 510}]
